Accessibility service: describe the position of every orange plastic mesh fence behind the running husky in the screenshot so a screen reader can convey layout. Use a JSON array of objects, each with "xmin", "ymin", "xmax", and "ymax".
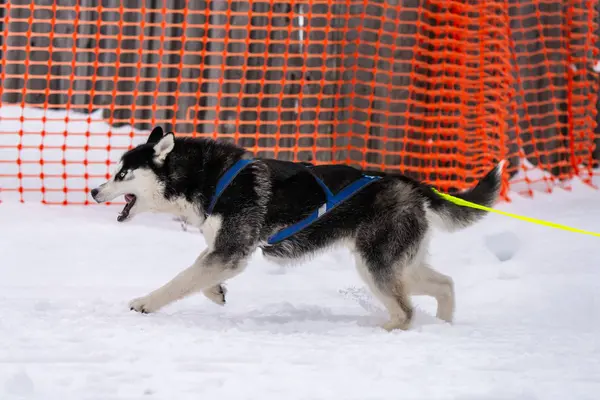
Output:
[{"xmin": 0, "ymin": 0, "xmax": 600, "ymax": 204}]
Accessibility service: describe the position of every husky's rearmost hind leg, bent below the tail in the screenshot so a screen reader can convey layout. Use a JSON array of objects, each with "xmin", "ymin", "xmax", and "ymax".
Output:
[{"xmin": 406, "ymin": 263, "xmax": 455, "ymax": 322}]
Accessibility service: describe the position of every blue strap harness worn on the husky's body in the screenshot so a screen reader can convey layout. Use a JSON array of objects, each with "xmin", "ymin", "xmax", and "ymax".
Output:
[{"xmin": 206, "ymin": 159, "xmax": 380, "ymax": 245}]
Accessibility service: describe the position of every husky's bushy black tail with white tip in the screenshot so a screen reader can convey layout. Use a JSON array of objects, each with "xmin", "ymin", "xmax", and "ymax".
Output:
[{"xmin": 427, "ymin": 160, "xmax": 506, "ymax": 232}]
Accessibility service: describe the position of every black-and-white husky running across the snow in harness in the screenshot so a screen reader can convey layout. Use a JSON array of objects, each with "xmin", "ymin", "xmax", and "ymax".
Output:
[{"xmin": 91, "ymin": 127, "xmax": 504, "ymax": 330}]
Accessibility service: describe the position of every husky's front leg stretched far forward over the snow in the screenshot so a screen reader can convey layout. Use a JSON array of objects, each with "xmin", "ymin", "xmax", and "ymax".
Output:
[{"xmin": 129, "ymin": 250, "xmax": 247, "ymax": 313}]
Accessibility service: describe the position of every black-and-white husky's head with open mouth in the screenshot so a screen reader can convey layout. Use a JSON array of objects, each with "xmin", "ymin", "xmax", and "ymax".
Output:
[{"xmin": 91, "ymin": 127, "xmax": 175, "ymax": 222}]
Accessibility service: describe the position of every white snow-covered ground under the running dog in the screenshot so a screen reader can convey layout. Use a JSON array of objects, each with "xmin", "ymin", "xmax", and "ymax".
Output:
[{"xmin": 0, "ymin": 179, "xmax": 600, "ymax": 400}]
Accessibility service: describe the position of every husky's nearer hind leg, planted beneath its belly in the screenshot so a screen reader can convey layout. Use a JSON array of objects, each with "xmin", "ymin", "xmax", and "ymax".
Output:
[{"xmin": 356, "ymin": 254, "xmax": 413, "ymax": 331}]
